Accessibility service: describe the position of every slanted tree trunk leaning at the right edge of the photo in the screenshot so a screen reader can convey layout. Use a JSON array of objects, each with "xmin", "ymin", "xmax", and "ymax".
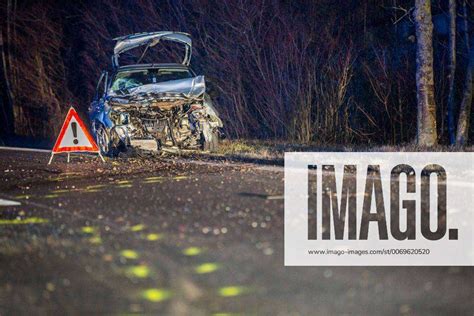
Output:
[{"xmin": 456, "ymin": 38, "xmax": 474, "ymax": 146}]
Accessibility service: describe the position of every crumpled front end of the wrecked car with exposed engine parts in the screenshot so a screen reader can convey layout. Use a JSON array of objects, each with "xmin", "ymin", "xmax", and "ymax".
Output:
[{"xmin": 92, "ymin": 72, "xmax": 222, "ymax": 154}]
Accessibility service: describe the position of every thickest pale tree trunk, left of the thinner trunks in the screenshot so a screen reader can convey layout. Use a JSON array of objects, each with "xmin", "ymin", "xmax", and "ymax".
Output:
[{"xmin": 415, "ymin": 0, "xmax": 437, "ymax": 146}]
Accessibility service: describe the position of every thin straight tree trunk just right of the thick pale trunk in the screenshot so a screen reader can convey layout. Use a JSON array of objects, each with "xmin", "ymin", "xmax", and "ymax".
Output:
[{"xmin": 448, "ymin": 0, "xmax": 456, "ymax": 145}]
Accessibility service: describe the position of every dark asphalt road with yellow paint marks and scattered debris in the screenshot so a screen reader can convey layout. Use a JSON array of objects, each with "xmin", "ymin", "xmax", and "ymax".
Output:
[{"xmin": 0, "ymin": 150, "xmax": 474, "ymax": 315}]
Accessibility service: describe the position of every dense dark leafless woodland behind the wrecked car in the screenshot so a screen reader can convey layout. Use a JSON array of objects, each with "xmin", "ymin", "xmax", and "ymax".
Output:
[{"xmin": 0, "ymin": 0, "xmax": 474, "ymax": 145}]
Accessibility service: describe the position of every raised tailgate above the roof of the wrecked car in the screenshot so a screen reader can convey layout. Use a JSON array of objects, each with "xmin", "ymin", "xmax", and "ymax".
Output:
[{"xmin": 112, "ymin": 31, "xmax": 192, "ymax": 67}]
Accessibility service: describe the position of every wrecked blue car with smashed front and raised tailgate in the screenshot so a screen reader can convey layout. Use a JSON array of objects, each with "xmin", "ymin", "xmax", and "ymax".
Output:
[{"xmin": 89, "ymin": 32, "xmax": 222, "ymax": 155}]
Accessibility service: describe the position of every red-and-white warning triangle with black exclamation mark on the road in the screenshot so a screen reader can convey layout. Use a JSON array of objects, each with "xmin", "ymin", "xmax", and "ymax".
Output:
[{"xmin": 53, "ymin": 107, "xmax": 99, "ymax": 153}]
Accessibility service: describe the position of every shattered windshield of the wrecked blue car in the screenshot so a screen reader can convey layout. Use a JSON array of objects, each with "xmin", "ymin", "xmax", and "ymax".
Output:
[{"xmin": 111, "ymin": 69, "xmax": 192, "ymax": 94}]
